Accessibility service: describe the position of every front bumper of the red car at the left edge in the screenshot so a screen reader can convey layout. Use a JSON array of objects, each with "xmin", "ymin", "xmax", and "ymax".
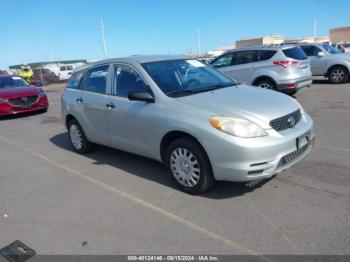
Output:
[{"xmin": 0, "ymin": 96, "xmax": 49, "ymax": 116}]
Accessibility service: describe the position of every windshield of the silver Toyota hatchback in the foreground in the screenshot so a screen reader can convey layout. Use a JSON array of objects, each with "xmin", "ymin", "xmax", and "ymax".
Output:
[{"xmin": 142, "ymin": 59, "xmax": 237, "ymax": 97}]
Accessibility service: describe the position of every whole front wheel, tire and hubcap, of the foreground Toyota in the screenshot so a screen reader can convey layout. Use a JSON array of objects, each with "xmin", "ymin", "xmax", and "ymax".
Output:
[{"xmin": 165, "ymin": 137, "xmax": 215, "ymax": 194}]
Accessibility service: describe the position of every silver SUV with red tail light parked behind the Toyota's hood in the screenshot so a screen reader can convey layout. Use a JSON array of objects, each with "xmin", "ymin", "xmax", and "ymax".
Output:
[{"xmin": 211, "ymin": 45, "xmax": 312, "ymax": 94}]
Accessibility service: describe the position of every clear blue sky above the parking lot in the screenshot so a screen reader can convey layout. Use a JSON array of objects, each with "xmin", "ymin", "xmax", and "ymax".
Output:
[{"xmin": 0, "ymin": 0, "xmax": 350, "ymax": 68}]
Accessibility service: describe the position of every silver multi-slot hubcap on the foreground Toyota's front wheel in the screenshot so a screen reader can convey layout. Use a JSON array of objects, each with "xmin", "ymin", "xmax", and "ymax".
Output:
[{"xmin": 170, "ymin": 148, "xmax": 200, "ymax": 187}]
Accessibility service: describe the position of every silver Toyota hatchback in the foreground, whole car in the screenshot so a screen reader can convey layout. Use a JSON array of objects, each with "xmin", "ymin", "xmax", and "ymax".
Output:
[{"xmin": 62, "ymin": 56, "xmax": 314, "ymax": 193}]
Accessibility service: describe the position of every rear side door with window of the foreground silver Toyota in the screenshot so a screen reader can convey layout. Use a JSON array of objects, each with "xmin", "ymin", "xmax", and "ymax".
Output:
[{"xmin": 78, "ymin": 65, "xmax": 109, "ymax": 145}]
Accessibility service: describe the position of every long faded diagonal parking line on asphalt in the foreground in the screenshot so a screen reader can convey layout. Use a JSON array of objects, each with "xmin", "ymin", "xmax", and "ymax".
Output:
[{"xmin": 0, "ymin": 136, "xmax": 272, "ymax": 256}]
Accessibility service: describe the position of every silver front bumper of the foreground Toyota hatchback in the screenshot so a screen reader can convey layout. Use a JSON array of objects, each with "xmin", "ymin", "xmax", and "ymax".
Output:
[{"xmin": 204, "ymin": 116, "xmax": 315, "ymax": 182}]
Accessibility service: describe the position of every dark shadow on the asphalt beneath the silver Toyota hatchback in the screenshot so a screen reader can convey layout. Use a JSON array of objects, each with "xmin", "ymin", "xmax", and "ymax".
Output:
[{"xmin": 50, "ymin": 133, "xmax": 269, "ymax": 199}]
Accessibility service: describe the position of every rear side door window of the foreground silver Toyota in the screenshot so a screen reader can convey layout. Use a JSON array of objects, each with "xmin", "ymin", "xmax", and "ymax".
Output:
[{"xmin": 83, "ymin": 65, "xmax": 109, "ymax": 94}]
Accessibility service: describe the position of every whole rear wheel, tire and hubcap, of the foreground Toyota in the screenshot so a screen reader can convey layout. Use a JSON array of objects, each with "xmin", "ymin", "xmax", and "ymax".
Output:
[{"xmin": 68, "ymin": 119, "xmax": 93, "ymax": 154}]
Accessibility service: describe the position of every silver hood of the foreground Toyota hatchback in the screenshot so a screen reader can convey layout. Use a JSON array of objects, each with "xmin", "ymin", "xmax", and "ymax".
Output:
[{"xmin": 178, "ymin": 85, "xmax": 300, "ymax": 126}]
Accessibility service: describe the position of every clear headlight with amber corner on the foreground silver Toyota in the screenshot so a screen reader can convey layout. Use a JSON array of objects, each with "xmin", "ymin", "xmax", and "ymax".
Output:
[{"xmin": 209, "ymin": 116, "xmax": 267, "ymax": 138}]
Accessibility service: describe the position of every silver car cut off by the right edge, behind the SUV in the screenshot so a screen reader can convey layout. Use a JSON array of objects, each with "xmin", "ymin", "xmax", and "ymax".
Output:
[{"xmin": 299, "ymin": 43, "xmax": 350, "ymax": 84}]
